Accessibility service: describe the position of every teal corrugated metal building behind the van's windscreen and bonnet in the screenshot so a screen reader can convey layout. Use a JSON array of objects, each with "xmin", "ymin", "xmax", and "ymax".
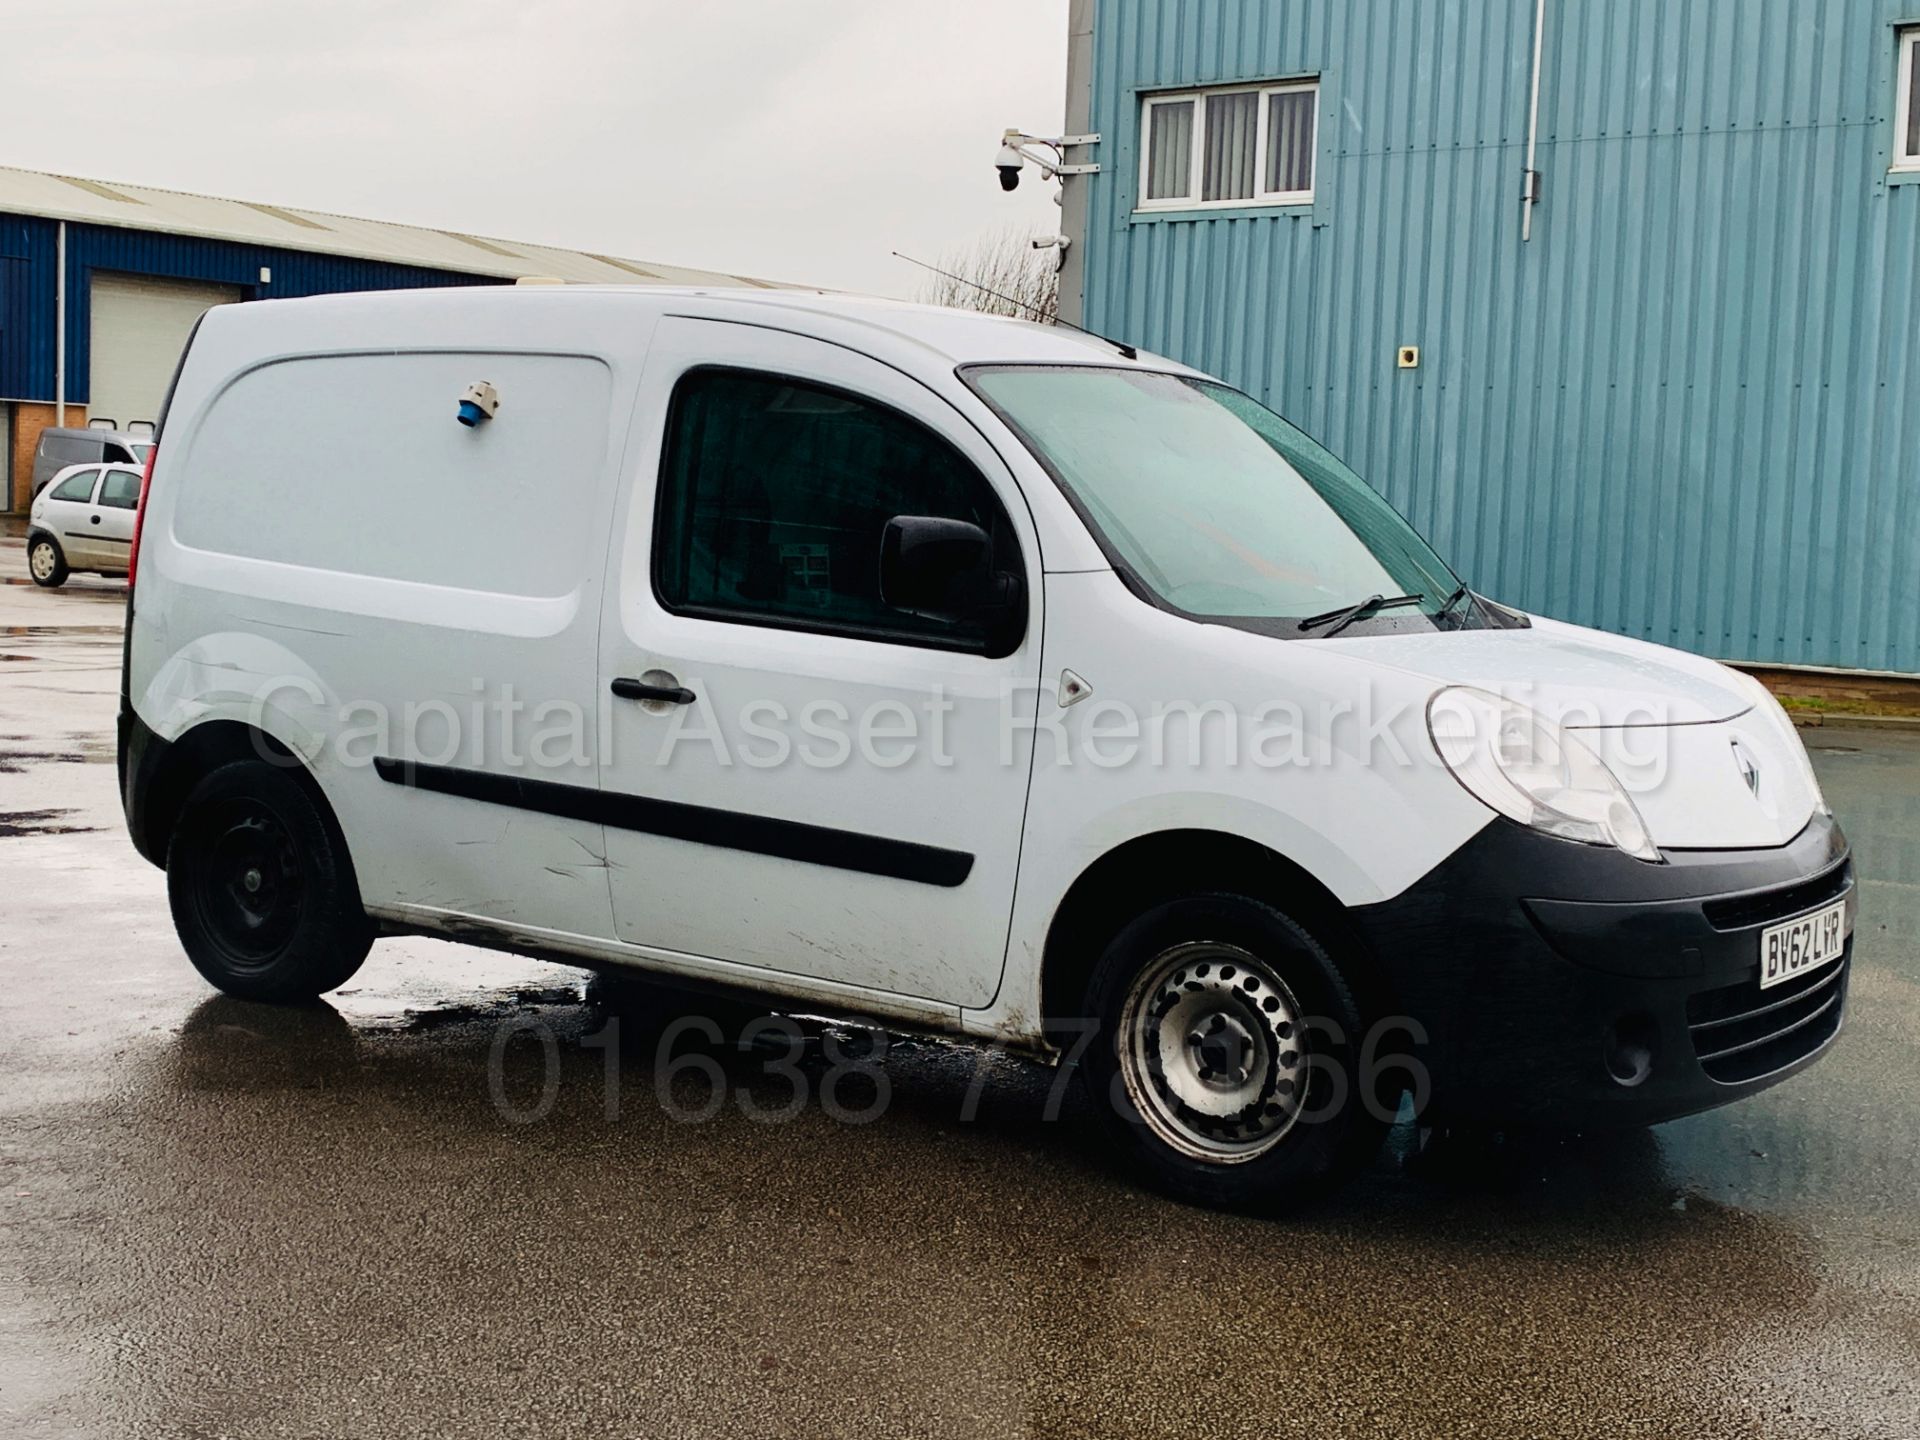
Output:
[{"xmin": 1062, "ymin": 0, "xmax": 1920, "ymax": 672}]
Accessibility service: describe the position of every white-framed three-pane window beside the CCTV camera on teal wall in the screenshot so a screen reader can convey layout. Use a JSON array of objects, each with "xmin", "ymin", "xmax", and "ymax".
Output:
[{"xmin": 1139, "ymin": 81, "xmax": 1319, "ymax": 209}]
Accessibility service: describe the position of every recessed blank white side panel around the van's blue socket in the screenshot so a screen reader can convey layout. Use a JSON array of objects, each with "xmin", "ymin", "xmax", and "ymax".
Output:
[{"xmin": 169, "ymin": 353, "xmax": 611, "ymax": 597}]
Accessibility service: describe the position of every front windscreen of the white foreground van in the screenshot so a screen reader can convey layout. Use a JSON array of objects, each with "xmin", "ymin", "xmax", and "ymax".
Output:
[{"xmin": 964, "ymin": 365, "xmax": 1496, "ymax": 636}]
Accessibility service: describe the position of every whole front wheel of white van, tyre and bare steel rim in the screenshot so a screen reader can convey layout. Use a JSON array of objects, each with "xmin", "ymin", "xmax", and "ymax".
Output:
[{"xmin": 1081, "ymin": 895, "xmax": 1386, "ymax": 1210}]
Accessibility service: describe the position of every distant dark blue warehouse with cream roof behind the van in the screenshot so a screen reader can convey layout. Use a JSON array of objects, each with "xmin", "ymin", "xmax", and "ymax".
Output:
[{"xmin": 0, "ymin": 167, "xmax": 766, "ymax": 509}]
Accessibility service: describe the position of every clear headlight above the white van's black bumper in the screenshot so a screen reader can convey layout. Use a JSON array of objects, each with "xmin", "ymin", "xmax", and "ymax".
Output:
[{"xmin": 1427, "ymin": 685, "xmax": 1661, "ymax": 862}]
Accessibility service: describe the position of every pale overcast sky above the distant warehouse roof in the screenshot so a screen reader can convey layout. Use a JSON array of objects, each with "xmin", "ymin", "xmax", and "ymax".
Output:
[{"xmin": 0, "ymin": 0, "xmax": 1066, "ymax": 296}]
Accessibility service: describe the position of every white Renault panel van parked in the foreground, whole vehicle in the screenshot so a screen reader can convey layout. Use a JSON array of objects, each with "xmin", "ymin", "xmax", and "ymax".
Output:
[{"xmin": 121, "ymin": 288, "xmax": 1855, "ymax": 1204}]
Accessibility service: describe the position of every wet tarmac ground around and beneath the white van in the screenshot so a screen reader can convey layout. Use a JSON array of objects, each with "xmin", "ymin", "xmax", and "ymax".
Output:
[{"xmin": 0, "ymin": 540, "xmax": 1920, "ymax": 1438}]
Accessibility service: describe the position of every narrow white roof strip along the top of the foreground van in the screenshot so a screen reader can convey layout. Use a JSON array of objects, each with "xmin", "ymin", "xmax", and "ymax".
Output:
[{"xmin": 213, "ymin": 284, "xmax": 1188, "ymax": 372}]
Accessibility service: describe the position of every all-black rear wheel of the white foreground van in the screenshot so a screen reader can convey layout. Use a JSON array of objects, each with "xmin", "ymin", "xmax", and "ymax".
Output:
[{"xmin": 167, "ymin": 760, "xmax": 372, "ymax": 1002}]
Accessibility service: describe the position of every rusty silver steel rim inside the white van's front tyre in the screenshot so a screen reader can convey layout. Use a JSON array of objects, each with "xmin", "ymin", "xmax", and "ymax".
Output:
[{"xmin": 1117, "ymin": 941, "xmax": 1308, "ymax": 1165}]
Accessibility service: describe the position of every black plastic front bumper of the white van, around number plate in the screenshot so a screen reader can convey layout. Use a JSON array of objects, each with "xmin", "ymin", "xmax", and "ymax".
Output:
[{"xmin": 1352, "ymin": 814, "xmax": 1857, "ymax": 1127}]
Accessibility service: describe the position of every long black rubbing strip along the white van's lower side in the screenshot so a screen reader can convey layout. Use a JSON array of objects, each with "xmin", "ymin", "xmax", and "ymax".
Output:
[{"xmin": 372, "ymin": 755, "xmax": 973, "ymax": 889}]
